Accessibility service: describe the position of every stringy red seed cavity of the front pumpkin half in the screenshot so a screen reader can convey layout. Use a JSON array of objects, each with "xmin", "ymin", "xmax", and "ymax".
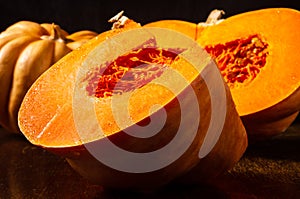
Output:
[{"xmin": 85, "ymin": 47, "xmax": 183, "ymax": 98}]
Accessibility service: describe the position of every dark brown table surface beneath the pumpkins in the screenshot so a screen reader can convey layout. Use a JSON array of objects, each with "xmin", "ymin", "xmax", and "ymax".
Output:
[{"xmin": 0, "ymin": 121, "xmax": 300, "ymax": 199}]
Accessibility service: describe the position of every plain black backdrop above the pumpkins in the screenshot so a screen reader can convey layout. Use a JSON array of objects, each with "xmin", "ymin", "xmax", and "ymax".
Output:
[{"xmin": 0, "ymin": 0, "xmax": 300, "ymax": 33}]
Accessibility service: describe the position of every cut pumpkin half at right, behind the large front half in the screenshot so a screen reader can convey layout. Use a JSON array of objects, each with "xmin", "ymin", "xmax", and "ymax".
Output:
[{"xmin": 197, "ymin": 8, "xmax": 300, "ymax": 141}]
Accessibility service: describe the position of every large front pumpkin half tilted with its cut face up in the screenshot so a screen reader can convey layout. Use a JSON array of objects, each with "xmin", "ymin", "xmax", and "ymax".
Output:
[{"xmin": 19, "ymin": 16, "xmax": 247, "ymax": 190}]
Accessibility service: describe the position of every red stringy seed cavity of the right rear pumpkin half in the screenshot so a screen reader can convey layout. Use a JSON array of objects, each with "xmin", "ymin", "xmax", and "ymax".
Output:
[{"xmin": 205, "ymin": 34, "xmax": 269, "ymax": 88}]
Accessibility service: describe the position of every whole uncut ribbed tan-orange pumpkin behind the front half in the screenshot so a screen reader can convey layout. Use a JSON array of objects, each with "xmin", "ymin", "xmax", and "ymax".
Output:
[{"xmin": 0, "ymin": 21, "xmax": 97, "ymax": 132}]
